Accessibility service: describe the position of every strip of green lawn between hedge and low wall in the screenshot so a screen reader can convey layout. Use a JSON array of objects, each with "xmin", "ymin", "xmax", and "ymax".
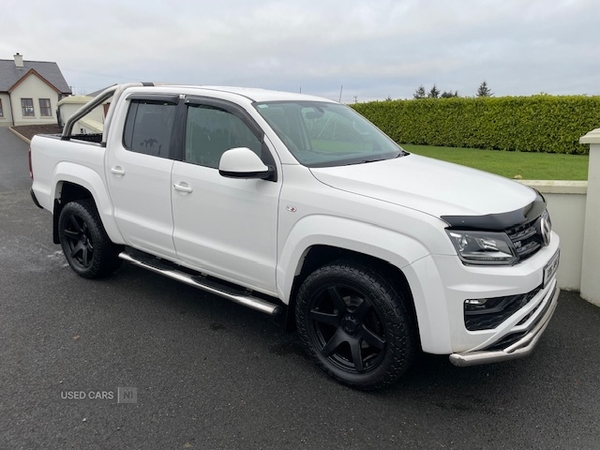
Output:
[{"xmin": 402, "ymin": 144, "xmax": 589, "ymax": 180}]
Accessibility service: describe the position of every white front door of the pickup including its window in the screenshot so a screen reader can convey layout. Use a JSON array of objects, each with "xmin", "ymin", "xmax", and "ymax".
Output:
[{"xmin": 173, "ymin": 98, "xmax": 281, "ymax": 293}]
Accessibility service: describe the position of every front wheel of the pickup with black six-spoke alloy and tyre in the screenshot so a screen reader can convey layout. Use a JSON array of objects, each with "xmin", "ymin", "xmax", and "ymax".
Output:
[{"xmin": 296, "ymin": 261, "xmax": 418, "ymax": 390}]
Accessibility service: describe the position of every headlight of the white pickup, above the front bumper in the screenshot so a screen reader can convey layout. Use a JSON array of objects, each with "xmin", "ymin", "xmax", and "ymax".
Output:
[{"xmin": 446, "ymin": 230, "xmax": 517, "ymax": 265}]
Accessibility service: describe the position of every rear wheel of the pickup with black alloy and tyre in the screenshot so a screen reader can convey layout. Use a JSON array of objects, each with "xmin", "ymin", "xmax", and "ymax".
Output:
[{"xmin": 58, "ymin": 199, "xmax": 122, "ymax": 278}]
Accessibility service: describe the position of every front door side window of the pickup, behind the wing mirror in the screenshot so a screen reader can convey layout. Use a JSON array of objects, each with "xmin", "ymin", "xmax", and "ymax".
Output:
[{"xmin": 185, "ymin": 105, "xmax": 261, "ymax": 169}]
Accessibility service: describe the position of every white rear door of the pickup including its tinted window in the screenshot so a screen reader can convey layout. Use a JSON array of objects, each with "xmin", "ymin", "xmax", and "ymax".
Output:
[{"xmin": 106, "ymin": 95, "xmax": 178, "ymax": 259}]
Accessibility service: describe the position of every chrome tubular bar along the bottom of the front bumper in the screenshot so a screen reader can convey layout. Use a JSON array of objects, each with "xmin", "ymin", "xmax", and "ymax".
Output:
[{"xmin": 450, "ymin": 279, "xmax": 560, "ymax": 367}]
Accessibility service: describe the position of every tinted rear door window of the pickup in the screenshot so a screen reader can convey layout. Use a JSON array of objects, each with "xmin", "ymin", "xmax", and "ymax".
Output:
[{"xmin": 123, "ymin": 100, "xmax": 177, "ymax": 158}]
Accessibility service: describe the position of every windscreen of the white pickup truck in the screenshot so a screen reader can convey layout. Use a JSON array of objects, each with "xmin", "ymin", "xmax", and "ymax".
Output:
[{"xmin": 255, "ymin": 102, "xmax": 405, "ymax": 167}]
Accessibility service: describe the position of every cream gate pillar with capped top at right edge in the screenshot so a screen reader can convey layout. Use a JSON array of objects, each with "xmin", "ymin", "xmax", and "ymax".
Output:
[{"xmin": 579, "ymin": 128, "xmax": 600, "ymax": 306}]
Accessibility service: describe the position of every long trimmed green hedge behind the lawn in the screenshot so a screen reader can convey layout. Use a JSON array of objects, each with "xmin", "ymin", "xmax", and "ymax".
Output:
[{"xmin": 351, "ymin": 95, "xmax": 600, "ymax": 154}]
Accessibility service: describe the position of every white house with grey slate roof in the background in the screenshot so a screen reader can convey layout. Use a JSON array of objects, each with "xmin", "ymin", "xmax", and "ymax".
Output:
[{"xmin": 0, "ymin": 53, "xmax": 71, "ymax": 126}]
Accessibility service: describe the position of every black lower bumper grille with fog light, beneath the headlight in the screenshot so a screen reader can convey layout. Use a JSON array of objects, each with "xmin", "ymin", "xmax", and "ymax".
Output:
[{"xmin": 464, "ymin": 285, "xmax": 542, "ymax": 331}]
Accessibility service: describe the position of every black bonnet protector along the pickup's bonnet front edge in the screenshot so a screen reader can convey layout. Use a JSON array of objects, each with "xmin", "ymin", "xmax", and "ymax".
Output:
[{"xmin": 441, "ymin": 193, "xmax": 546, "ymax": 231}]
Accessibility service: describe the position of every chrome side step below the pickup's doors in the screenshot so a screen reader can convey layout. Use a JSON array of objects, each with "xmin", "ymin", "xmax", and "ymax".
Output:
[{"xmin": 119, "ymin": 251, "xmax": 283, "ymax": 316}]
